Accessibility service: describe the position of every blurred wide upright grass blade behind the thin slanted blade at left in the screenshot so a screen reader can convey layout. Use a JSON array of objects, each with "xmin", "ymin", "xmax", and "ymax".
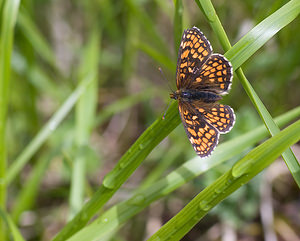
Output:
[{"xmin": 69, "ymin": 31, "xmax": 99, "ymax": 218}]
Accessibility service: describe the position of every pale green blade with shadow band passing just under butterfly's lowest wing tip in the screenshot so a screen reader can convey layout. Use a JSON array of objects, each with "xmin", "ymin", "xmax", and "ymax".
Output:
[{"xmin": 62, "ymin": 107, "xmax": 300, "ymax": 241}]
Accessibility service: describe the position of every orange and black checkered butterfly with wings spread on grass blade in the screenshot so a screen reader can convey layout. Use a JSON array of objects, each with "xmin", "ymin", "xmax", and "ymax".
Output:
[{"xmin": 170, "ymin": 27, "xmax": 235, "ymax": 157}]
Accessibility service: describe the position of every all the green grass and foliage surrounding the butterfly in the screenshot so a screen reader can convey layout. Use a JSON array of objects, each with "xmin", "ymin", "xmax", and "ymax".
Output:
[{"xmin": 0, "ymin": 0, "xmax": 300, "ymax": 240}]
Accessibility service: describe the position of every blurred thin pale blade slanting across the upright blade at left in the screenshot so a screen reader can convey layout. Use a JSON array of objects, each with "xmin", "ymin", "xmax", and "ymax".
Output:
[{"xmin": 5, "ymin": 73, "xmax": 94, "ymax": 184}]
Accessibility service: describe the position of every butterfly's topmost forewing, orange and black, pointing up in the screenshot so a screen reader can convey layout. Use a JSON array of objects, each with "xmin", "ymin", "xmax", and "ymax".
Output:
[{"xmin": 176, "ymin": 27, "xmax": 212, "ymax": 89}]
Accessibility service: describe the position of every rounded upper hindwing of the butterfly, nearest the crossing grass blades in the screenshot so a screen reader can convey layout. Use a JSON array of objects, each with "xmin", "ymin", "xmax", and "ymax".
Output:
[{"xmin": 189, "ymin": 54, "xmax": 233, "ymax": 95}]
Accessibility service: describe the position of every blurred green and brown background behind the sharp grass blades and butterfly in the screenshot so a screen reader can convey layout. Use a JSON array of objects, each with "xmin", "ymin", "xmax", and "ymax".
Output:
[{"xmin": 1, "ymin": 0, "xmax": 300, "ymax": 240}]
